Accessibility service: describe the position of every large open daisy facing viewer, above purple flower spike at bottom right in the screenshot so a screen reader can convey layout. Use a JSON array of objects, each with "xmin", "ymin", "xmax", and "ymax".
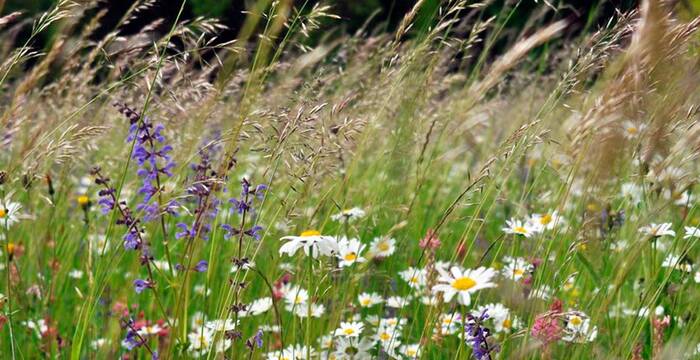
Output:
[{"xmin": 433, "ymin": 266, "xmax": 496, "ymax": 305}]
